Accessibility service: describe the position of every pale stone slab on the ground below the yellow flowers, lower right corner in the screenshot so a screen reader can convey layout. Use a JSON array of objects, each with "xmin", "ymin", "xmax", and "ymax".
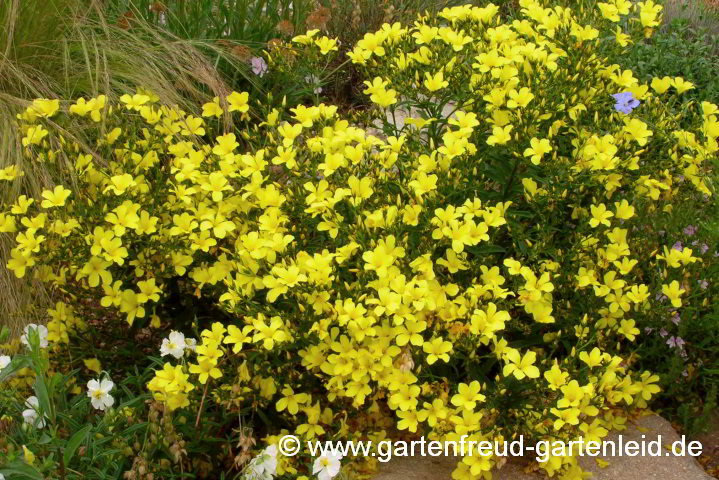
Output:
[{"xmin": 372, "ymin": 415, "xmax": 712, "ymax": 480}]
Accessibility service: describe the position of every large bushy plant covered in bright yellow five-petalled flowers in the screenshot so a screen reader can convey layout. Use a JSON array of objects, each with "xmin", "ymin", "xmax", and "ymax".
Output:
[{"xmin": 0, "ymin": 0, "xmax": 719, "ymax": 479}]
